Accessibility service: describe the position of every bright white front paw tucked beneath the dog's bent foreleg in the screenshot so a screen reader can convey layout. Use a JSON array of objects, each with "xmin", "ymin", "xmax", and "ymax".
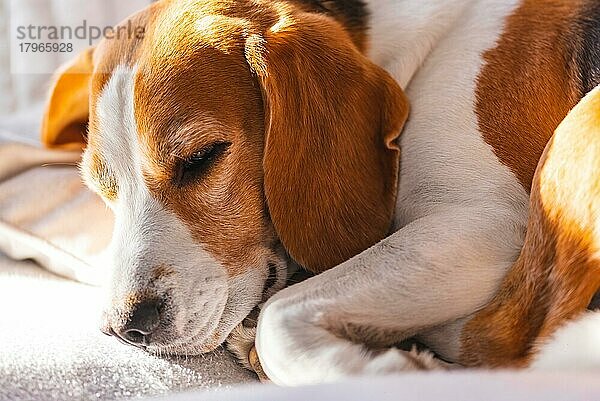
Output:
[{"xmin": 256, "ymin": 299, "xmax": 448, "ymax": 386}]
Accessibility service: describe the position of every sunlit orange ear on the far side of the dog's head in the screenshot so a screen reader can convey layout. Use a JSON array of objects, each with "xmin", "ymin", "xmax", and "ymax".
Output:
[{"xmin": 41, "ymin": 47, "xmax": 94, "ymax": 148}]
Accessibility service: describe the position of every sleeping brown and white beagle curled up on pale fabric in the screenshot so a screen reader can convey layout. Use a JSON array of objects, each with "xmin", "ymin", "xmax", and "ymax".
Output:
[{"xmin": 42, "ymin": 0, "xmax": 600, "ymax": 385}]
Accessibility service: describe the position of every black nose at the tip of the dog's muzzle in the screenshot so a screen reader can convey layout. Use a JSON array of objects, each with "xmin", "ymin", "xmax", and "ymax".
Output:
[{"xmin": 111, "ymin": 300, "xmax": 160, "ymax": 346}]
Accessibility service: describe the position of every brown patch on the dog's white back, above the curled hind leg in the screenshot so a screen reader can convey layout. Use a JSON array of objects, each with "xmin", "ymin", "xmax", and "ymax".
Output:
[{"xmin": 475, "ymin": 0, "xmax": 581, "ymax": 190}]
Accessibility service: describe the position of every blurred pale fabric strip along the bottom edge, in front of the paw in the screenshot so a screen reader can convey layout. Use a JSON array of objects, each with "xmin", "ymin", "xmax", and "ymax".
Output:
[{"xmin": 144, "ymin": 372, "xmax": 600, "ymax": 401}]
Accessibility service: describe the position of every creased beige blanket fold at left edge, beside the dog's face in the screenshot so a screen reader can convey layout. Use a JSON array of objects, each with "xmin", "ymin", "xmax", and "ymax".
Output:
[{"xmin": 0, "ymin": 131, "xmax": 112, "ymax": 283}]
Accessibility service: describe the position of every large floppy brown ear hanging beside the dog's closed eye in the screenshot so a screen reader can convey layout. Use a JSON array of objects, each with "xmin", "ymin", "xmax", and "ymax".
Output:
[{"xmin": 246, "ymin": 13, "xmax": 408, "ymax": 272}]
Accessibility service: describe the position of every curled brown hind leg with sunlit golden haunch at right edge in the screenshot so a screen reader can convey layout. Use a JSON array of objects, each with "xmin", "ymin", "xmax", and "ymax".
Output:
[{"xmin": 461, "ymin": 88, "xmax": 600, "ymax": 367}]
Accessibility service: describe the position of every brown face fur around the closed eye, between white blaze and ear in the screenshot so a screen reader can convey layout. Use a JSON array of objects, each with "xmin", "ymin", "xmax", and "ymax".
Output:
[{"xmin": 135, "ymin": 7, "xmax": 275, "ymax": 275}]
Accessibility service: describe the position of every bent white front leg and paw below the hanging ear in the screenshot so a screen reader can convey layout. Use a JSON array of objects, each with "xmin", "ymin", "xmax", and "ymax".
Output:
[{"xmin": 256, "ymin": 205, "xmax": 524, "ymax": 385}]
